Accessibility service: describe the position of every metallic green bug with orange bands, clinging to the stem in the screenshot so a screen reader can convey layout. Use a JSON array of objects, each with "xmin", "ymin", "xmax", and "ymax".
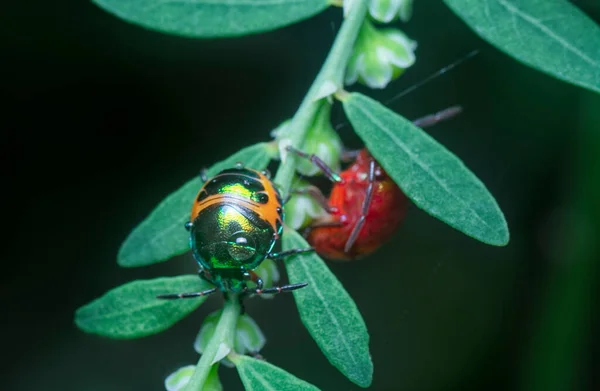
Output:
[{"xmin": 158, "ymin": 163, "xmax": 314, "ymax": 299}]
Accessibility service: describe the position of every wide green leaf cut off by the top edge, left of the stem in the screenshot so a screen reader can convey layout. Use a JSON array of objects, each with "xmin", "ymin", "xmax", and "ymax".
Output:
[{"xmin": 92, "ymin": 0, "xmax": 329, "ymax": 38}]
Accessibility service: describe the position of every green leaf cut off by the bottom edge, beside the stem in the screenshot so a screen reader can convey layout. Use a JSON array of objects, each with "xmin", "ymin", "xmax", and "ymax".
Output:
[{"xmin": 230, "ymin": 354, "xmax": 319, "ymax": 391}]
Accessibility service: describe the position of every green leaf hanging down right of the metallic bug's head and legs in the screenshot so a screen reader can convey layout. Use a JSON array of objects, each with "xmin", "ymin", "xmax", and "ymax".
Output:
[{"xmin": 283, "ymin": 229, "xmax": 373, "ymax": 387}]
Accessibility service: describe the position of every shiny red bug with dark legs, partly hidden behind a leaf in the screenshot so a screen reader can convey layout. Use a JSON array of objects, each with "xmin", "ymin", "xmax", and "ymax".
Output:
[{"xmin": 288, "ymin": 106, "xmax": 461, "ymax": 261}]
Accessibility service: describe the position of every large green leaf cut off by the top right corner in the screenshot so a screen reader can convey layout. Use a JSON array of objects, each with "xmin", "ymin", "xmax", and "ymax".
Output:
[{"xmin": 444, "ymin": 0, "xmax": 600, "ymax": 92}]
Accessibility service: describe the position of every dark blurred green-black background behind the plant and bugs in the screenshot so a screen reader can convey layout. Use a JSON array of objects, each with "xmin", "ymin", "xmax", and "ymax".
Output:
[{"xmin": 0, "ymin": 0, "xmax": 600, "ymax": 391}]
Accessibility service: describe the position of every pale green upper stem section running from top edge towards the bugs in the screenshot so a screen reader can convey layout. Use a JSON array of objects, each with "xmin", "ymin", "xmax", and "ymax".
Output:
[{"xmin": 275, "ymin": 0, "xmax": 369, "ymax": 195}]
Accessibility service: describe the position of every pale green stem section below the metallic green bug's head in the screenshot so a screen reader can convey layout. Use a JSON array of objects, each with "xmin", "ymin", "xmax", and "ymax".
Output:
[{"xmin": 184, "ymin": 294, "xmax": 240, "ymax": 391}]
